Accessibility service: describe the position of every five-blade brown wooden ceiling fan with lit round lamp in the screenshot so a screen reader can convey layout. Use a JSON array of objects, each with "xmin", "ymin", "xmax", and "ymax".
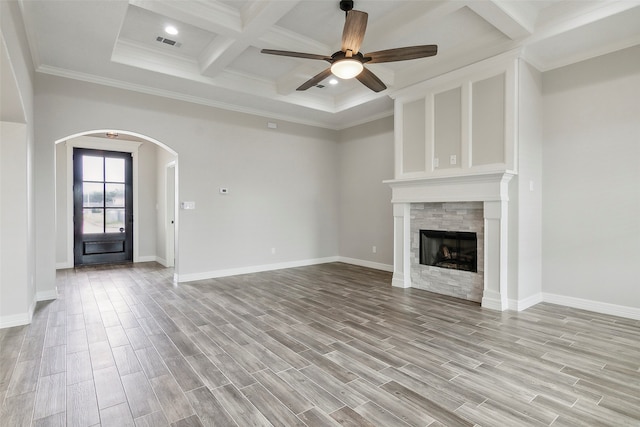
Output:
[{"xmin": 261, "ymin": 0, "xmax": 438, "ymax": 92}]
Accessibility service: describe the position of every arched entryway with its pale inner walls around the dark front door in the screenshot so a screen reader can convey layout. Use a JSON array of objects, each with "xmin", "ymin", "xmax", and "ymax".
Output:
[{"xmin": 55, "ymin": 129, "xmax": 179, "ymax": 277}]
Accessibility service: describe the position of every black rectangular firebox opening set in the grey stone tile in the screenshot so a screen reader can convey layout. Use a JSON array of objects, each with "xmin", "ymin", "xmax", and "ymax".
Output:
[{"xmin": 420, "ymin": 230, "xmax": 478, "ymax": 272}]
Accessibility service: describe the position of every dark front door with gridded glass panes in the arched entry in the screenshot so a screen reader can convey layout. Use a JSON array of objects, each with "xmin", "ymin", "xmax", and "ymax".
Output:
[{"xmin": 73, "ymin": 148, "xmax": 133, "ymax": 266}]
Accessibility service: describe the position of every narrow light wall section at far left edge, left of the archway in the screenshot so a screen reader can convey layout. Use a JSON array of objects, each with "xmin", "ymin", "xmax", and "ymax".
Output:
[{"xmin": 0, "ymin": 2, "xmax": 37, "ymax": 327}]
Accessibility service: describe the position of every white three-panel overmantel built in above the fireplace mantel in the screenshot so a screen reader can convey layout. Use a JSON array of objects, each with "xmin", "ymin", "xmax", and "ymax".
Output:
[{"xmin": 395, "ymin": 50, "xmax": 518, "ymax": 179}]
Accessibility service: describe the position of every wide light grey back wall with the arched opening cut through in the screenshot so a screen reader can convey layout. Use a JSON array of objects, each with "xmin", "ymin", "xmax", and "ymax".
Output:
[{"xmin": 36, "ymin": 75, "xmax": 339, "ymax": 280}]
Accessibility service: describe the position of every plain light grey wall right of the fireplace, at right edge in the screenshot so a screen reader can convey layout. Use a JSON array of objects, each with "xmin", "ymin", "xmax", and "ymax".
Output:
[{"xmin": 542, "ymin": 46, "xmax": 640, "ymax": 312}]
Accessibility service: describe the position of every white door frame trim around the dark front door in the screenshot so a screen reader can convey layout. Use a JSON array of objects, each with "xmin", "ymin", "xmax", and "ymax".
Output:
[{"xmin": 64, "ymin": 135, "xmax": 144, "ymax": 268}]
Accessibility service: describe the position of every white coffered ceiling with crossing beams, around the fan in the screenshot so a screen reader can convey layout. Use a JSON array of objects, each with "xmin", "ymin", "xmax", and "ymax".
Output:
[{"xmin": 20, "ymin": 0, "xmax": 640, "ymax": 129}]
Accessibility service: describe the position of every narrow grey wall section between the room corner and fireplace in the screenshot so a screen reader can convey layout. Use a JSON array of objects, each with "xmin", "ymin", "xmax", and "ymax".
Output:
[{"xmin": 339, "ymin": 117, "xmax": 394, "ymax": 271}]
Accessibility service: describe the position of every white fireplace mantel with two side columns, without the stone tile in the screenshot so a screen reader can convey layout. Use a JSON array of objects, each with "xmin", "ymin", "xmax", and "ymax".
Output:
[{"xmin": 386, "ymin": 172, "xmax": 514, "ymax": 311}]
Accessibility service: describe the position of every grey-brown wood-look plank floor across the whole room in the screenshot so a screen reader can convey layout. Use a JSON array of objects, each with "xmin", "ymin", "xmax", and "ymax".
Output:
[{"xmin": 0, "ymin": 263, "xmax": 640, "ymax": 427}]
